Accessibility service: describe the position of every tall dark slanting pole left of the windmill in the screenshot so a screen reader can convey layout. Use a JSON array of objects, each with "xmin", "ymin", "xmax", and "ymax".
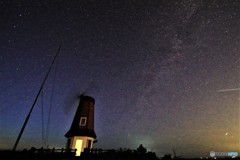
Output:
[{"xmin": 13, "ymin": 44, "xmax": 61, "ymax": 151}]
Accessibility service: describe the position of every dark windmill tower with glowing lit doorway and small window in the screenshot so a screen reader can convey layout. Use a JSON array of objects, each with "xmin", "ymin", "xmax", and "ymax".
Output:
[{"xmin": 65, "ymin": 95, "xmax": 97, "ymax": 156}]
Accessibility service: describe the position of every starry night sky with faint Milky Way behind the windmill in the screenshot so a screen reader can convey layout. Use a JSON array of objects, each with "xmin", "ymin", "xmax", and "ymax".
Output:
[{"xmin": 0, "ymin": 0, "xmax": 240, "ymax": 157}]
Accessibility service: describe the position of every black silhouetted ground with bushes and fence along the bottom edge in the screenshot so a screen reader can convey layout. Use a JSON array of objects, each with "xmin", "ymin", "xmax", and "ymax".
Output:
[{"xmin": 0, "ymin": 145, "xmax": 238, "ymax": 160}]
